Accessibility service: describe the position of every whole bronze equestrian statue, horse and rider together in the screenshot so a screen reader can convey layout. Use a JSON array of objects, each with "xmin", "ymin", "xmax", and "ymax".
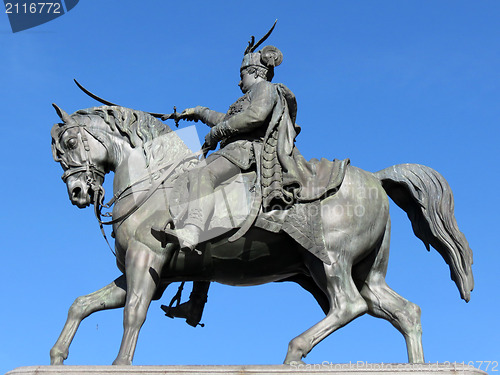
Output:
[{"xmin": 50, "ymin": 29, "xmax": 474, "ymax": 364}]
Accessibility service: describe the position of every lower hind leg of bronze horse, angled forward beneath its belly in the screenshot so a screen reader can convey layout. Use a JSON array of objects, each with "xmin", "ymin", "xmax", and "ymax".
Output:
[{"xmin": 284, "ymin": 256, "xmax": 368, "ymax": 364}]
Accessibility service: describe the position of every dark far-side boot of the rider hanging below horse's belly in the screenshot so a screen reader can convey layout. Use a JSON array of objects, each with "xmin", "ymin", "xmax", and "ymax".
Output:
[{"xmin": 161, "ymin": 281, "xmax": 210, "ymax": 327}]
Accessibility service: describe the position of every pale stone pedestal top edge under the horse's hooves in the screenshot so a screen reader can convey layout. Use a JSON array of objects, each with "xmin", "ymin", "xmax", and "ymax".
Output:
[{"xmin": 5, "ymin": 362, "xmax": 487, "ymax": 375}]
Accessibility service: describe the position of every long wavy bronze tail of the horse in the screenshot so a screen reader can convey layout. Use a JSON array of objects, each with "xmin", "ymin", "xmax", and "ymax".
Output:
[{"xmin": 375, "ymin": 164, "xmax": 474, "ymax": 302}]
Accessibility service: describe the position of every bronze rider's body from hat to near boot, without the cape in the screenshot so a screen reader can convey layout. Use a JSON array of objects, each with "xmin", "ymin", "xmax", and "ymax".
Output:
[{"xmin": 166, "ymin": 46, "xmax": 293, "ymax": 250}]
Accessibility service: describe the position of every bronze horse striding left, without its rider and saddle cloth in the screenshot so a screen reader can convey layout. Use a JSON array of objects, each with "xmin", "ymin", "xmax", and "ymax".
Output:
[{"xmin": 50, "ymin": 104, "xmax": 474, "ymax": 365}]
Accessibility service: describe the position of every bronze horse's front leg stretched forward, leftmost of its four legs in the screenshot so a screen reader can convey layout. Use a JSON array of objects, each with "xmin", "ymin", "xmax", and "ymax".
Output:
[{"xmin": 50, "ymin": 275, "xmax": 126, "ymax": 365}]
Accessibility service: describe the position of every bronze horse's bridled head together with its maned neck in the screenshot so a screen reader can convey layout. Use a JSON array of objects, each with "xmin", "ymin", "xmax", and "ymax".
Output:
[{"xmin": 51, "ymin": 104, "xmax": 192, "ymax": 208}]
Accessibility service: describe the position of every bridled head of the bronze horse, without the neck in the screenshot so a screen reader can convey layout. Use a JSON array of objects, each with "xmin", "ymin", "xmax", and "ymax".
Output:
[{"xmin": 51, "ymin": 104, "xmax": 109, "ymax": 208}]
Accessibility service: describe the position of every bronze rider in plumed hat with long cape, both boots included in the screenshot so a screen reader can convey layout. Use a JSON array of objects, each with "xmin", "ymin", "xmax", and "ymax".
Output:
[{"xmin": 164, "ymin": 37, "xmax": 348, "ymax": 326}]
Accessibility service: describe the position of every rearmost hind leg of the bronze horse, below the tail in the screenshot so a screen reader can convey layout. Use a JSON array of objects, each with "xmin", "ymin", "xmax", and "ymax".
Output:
[{"xmin": 360, "ymin": 220, "xmax": 424, "ymax": 363}]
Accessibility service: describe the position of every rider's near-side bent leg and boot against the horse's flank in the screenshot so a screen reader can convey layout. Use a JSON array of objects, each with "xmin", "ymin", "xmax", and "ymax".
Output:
[{"xmin": 176, "ymin": 155, "xmax": 240, "ymax": 250}]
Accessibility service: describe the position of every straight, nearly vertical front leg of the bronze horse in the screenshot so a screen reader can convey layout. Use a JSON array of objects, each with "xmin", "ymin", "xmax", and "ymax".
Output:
[{"xmin": 113, "ymin": 242, "xmax": 166, "ymax": 365}]
